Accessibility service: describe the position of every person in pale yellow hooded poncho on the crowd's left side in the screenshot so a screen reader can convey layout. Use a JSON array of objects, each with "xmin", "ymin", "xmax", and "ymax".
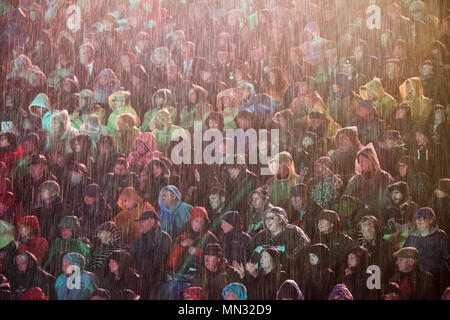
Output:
[{"xmin": 103, "ymin": 90, "xmax": 140, "ymax": 135}]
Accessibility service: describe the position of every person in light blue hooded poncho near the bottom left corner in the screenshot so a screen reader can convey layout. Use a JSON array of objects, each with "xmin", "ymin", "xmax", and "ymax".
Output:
[{"xmin": 55, "ymin": 252, "xmax": 99, "ymax": 300}]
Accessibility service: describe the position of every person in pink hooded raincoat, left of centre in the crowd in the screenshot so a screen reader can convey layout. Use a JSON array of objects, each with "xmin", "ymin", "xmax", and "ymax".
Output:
[{"xmin": 128, "ymin": 132, "xmax": 164, "ymax": 167}]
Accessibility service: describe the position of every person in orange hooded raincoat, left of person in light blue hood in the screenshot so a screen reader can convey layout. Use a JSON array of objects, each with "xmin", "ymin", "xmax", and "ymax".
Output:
[{"xmin": 113, "ymin": 187, "xmax": 155, "ymax": 244}]
